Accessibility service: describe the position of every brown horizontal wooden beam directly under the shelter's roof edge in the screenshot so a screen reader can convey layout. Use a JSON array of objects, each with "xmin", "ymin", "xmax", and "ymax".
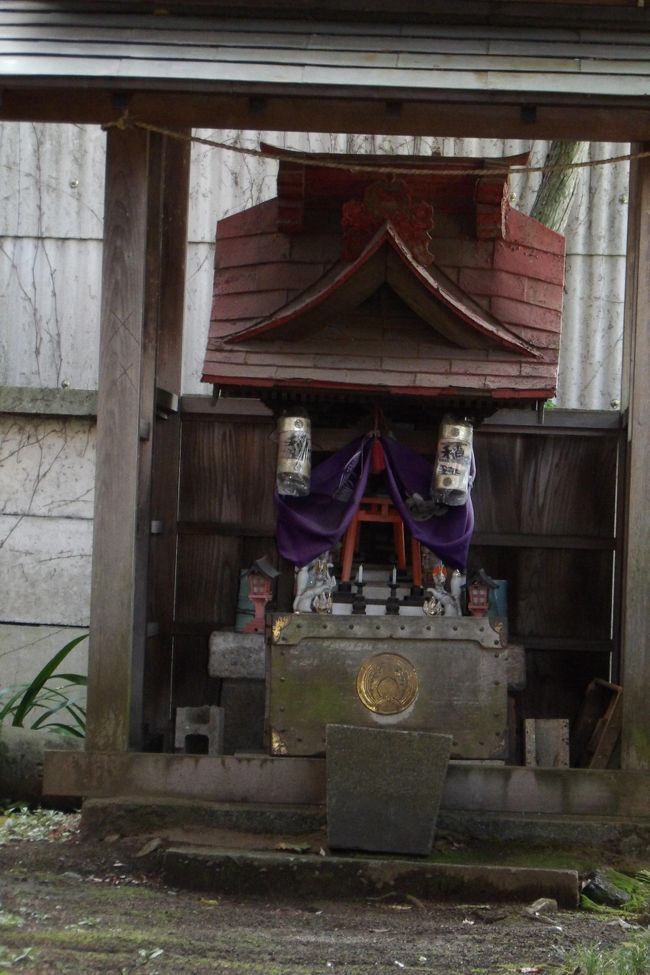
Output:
[{"xmin": 0, "ymin": 86, "xmax": 650, "ymax": 142}]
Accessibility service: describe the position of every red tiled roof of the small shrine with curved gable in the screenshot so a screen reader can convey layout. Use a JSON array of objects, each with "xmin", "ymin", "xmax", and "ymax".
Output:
[{"xmin": 203, "ymin": 145, "xmax": 564, "ymax": 403}]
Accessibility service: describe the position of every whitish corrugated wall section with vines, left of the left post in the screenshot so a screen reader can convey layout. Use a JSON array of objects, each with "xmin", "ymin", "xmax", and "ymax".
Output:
[{"xmin": 0, "ymin": 123, "xmax": 105, "ymax": 389}]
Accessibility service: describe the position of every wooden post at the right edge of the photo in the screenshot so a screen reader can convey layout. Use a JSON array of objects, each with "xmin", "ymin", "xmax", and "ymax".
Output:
[{"xmin": 621, "ymin": 146, "xmax": 650, "ymax": 769}]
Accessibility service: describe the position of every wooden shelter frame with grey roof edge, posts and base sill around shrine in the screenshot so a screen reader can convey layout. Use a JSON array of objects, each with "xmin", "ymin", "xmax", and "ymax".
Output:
[{"xmin": 0, "ymin": 0, "xmax": 650, "ymax": 816}]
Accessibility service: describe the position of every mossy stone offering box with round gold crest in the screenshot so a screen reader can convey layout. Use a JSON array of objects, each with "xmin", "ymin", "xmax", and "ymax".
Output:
[{"xmin": 266, "ymin": 613, "xmax": 520, "ymax": 760}]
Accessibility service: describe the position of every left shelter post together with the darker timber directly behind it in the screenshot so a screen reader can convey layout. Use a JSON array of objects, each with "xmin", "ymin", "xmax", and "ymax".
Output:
[{"xmin": 87, "ymin": 129, "xmax": 190, "ymax": 751}]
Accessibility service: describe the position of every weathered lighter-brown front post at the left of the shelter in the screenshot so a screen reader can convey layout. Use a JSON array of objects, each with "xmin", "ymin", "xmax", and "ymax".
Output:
[{"xmin": 86, "ymin": 128, "xmax": 187, "ymax": 751}]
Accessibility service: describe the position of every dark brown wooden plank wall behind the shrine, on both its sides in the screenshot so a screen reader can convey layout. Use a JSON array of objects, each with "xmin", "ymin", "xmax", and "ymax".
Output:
[{"xmin": 174, "ymin": 414, "xmax": 618, "ymax": 740}]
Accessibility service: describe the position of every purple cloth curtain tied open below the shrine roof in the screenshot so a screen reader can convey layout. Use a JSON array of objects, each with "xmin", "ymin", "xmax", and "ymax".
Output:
[{"xmin": 275, "ymin": 435, "xmax": 474, "ymax": 571}]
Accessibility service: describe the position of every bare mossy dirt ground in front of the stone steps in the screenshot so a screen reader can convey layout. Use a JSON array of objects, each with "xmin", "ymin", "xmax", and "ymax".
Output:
[{"xmin": 0, "ymin": 816, "xmax": 650, "ymax": 975}]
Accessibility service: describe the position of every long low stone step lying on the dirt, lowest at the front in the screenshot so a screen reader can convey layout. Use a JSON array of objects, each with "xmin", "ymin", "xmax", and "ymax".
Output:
[{"xmin": 163, "ymin": 847, "xmax": 579, "ymax": 908}]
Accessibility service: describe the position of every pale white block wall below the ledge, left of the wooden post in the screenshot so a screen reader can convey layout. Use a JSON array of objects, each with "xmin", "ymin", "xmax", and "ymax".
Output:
[{"xmin": 0, "ymin": 414, "xmax": 95, "ymax": 687}]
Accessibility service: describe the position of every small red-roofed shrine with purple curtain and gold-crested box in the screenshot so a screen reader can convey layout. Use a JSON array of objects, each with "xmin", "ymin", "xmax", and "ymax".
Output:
[{"xmin": 203, "ymin": 152, "xmax": 564, "ymax": 761}]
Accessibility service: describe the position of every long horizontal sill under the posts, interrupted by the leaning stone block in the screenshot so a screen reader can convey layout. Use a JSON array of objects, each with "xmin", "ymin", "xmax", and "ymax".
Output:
[{"xmin": 44, "ymin": 751, "xmax": 650, "ymax": 822}]
